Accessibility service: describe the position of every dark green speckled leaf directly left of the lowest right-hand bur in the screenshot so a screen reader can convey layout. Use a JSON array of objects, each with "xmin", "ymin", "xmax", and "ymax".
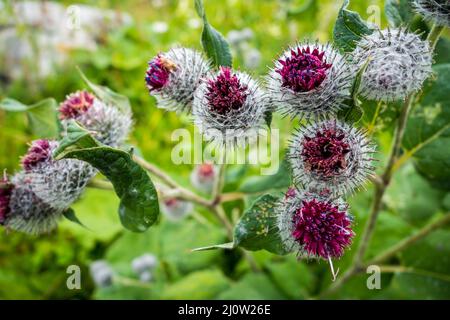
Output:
[{"xmin": 234, "ymin": 194, "xmax": 286, "ymax": 254}]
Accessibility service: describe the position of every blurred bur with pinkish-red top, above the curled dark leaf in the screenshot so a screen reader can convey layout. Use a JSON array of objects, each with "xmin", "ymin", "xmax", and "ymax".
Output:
[{"xmin": 59, "ymin": 91, "xmax": 133, "ymax": 147}]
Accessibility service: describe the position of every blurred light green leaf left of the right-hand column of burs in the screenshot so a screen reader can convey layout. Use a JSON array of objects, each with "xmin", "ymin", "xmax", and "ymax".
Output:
[{"xmin": 239, "ymin": 159, "xmax": 292, "ymax": 193}]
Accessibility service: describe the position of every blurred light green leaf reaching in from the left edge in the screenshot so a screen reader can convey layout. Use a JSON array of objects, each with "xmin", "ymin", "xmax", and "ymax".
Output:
[{"xmin": 0, "ymin": 98, "xmax": 59, "ymax": 138}]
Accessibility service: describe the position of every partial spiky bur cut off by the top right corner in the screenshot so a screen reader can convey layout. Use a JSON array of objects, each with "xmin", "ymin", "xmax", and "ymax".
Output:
[{"xmin": 413, "ymin": 0, "xmax": 450, "ymax": 27}]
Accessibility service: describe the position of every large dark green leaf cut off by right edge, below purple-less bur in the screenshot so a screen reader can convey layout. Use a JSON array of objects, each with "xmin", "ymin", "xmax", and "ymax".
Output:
[{"xmin": 403, "ymin": 64, "xmax": 450, "ymax": 190}]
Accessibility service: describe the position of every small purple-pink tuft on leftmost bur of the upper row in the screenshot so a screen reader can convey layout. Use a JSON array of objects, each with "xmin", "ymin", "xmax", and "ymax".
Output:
[{"xmin": 145, "ymin": 54, "xmax": 177, "ymax": 93}]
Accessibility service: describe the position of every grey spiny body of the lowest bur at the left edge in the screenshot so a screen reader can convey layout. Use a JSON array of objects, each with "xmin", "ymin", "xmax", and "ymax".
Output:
[{"xmin": 4, "ymin": 172, "xmax": 62, "ymax": 235}]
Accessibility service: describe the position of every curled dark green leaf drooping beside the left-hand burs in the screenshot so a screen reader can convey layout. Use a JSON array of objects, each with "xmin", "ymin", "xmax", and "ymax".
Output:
[{"xmin": 54, "ymin": 122, "xmax": 159, "ymax": 232}]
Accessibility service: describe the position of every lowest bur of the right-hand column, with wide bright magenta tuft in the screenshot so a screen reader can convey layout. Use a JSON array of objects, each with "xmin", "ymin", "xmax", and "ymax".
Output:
[{"xmin": 277, "ymin": 190, "xmax": 354, "ymax": 260}]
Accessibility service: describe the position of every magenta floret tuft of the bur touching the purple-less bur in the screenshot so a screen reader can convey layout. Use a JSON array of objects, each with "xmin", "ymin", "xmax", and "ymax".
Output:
[{"xmin": 275, "ymin": 46, "xmax": 332, "ymax": 92}]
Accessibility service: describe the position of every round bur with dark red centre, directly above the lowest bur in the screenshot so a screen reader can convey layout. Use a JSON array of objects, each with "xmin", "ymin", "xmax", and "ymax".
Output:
[{"xmin": 289, "ymin": 120, "xmax": 374, "ymax": 195}]
